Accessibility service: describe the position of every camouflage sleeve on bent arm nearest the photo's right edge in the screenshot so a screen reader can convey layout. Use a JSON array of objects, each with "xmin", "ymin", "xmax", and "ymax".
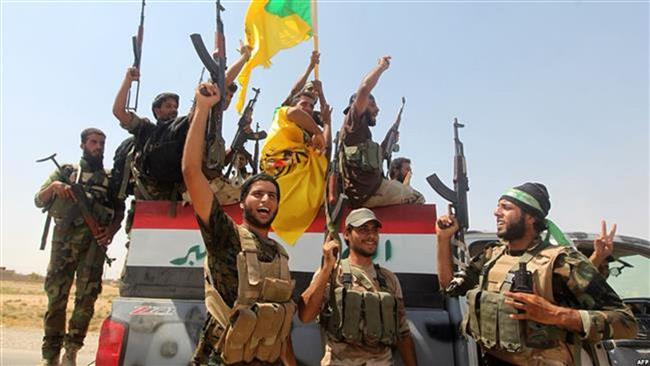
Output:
[{"xmin": 553, "ymin": 249, "xmax": 637, "ymax": 342}]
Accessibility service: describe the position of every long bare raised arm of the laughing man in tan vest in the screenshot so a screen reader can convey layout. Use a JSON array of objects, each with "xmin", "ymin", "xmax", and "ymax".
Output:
[{"xmin": 182, "ymin": 83, "xmax": 221, "ymax": 223}]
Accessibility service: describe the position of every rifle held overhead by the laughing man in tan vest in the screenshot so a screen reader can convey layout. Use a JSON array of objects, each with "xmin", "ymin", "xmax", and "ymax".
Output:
[{"xmin": 190, "ymin": 0, "xmax": 226, "ymax": 172}]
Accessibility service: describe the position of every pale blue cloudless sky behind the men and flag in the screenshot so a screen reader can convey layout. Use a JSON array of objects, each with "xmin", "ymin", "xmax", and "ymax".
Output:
[{"xmin": 0, "ymin": 0, "xmax": 650, "ymax": 278}]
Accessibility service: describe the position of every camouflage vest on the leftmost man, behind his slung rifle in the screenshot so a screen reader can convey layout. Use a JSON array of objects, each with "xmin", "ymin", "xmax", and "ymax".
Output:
[{"xmin": 48, "ymin": 164, "xmax": 115, "ymax": 227}]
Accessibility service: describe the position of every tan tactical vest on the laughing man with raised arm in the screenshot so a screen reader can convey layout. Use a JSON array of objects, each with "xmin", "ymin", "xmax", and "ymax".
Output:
[{"xmin": 205, "ymin": 226, "xmax": 296, "ymax": 364}]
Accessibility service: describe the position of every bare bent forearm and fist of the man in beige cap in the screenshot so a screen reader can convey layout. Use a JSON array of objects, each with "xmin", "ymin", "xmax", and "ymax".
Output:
[{"xmin": 298, "ymin": 240, "xmax": 339, "ymax": 323}]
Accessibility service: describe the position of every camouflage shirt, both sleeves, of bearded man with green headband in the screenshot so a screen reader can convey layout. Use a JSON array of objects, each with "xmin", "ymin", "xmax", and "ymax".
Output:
[{"xmin": 443, "ymin": 239, "xmax": 637, "ymax": 343}]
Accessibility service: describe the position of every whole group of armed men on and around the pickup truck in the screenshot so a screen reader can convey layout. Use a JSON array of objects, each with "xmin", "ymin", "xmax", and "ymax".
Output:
[{"xmin": 36, "ymin": 47, "xmax": 637, "ymax": 365}]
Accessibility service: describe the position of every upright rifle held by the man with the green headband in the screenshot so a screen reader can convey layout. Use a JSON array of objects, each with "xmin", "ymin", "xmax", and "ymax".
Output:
[{"xmin": 427, "ymin": 118, "xmax": 469, "ymax": 266}]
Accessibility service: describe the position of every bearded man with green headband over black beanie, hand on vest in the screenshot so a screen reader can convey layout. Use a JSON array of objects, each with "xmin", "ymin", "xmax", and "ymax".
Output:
[{"xmin": 437, "ymin": 183, "xmax": 637, "ymax": 365}]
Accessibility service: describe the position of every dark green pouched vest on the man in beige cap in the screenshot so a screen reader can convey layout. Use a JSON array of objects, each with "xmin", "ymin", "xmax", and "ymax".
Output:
[{"xmin": 320, "ymin": 259, "xmax": 399, "ymax": 346}]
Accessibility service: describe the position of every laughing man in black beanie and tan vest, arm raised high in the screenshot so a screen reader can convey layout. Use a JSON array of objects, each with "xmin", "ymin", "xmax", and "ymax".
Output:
[{"xmin": 182, "ymin": 83, "xmax": 296, "ymax": 365}]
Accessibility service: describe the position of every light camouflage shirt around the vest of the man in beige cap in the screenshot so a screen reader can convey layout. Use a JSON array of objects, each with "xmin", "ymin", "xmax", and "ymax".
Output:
[{"xmin": 312, "ymin": 264, "xmax": 410, "ymax": 366}]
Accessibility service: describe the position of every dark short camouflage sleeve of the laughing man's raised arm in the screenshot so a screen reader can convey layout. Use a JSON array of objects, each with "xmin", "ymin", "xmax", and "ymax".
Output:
[{"xmin": 196, "ymin": 195, "xmax": 239, "ymax": 255}]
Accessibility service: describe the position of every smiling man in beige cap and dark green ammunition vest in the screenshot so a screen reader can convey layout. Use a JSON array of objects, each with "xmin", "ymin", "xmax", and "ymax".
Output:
[{"xmin": 298, "ymin": 208, "xmax": 417, "ymax": 366}]
